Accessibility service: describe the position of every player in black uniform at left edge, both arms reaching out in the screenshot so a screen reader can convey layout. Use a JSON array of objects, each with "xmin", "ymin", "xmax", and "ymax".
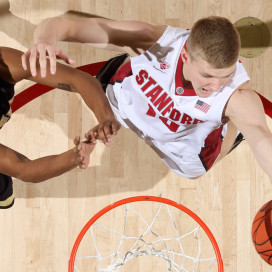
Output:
[{"xmin": 0, "ymin": 47, "xmax": 120, "ymax": 209}]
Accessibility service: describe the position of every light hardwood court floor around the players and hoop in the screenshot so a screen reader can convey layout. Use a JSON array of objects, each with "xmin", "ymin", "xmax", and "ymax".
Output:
[{"xmin": 0, "ymin": 0, "xmax": 272, "ymax": 272}]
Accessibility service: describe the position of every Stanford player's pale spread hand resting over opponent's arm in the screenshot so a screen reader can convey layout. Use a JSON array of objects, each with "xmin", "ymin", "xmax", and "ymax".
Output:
[{"xmin": 22, "ymin": 42, "xmax": 75, "ymax": 77}]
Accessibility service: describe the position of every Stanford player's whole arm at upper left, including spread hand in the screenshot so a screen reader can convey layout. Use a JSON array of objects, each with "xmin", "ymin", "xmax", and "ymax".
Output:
[{"xmin": 22, "ymin": 17, "xmax": 165, "ymax": 76}]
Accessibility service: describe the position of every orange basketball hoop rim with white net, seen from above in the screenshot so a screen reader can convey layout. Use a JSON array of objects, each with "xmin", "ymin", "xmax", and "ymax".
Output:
[{"xmin": 68, "ymin": 196, "xmax": 223, "ymax": 272}]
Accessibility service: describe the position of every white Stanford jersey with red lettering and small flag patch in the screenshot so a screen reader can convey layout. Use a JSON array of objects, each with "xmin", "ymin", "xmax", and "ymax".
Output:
[{"xmin": 107, "ymin": 26, "xmax": 249, "ymax": 177}]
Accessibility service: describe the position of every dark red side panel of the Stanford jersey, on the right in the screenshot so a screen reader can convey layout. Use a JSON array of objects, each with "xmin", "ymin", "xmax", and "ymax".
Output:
[{"xmin": 199, "ymin": 127, "xmax": 223, "ymax": 171}]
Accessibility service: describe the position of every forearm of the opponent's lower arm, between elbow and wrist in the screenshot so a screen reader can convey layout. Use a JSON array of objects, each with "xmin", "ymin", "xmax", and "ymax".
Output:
[{"xmin": 16, "ymin": 149, "xmax": 80, "ymax": 183}]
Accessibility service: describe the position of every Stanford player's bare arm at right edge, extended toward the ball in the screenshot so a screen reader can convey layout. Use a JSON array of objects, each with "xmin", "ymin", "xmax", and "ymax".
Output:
[{"xmin": 226, "ymin": 89, "xmax": 272, "ymax": 183}]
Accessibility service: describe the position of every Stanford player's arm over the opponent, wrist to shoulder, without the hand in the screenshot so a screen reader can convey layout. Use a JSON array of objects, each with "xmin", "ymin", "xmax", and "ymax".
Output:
[{"xmin": 34, "ymin": 17, "xmax": 162, "ymax": 50}]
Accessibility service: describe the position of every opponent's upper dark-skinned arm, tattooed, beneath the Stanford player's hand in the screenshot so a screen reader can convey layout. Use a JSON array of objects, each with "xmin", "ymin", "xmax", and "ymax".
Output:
[{"xmin": 0, "ymin": 48, "xmax": 121, "ymax": 145}]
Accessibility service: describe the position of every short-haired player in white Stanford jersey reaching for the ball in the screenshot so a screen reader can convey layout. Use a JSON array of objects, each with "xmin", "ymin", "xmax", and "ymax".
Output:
[{"xmin": 22, "ymin": 17, "xmax": 272, "ymax": 181}]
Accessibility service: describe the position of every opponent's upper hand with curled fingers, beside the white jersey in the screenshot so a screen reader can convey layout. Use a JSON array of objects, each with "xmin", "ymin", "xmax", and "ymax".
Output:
[{"xmin": 85, "ymin": 119, "xmax": 121, "ymax": 145}]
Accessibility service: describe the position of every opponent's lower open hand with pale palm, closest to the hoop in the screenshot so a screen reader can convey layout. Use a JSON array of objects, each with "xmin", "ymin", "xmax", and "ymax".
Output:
[{"xmin": 74, "ymin": 136, "xmax": 95, "ymax": 169}]
